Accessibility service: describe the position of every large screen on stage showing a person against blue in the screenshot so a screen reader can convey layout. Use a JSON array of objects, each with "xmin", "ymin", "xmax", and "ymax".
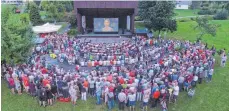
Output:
[{"xmin": 94, "ymin": 18, "xmax": 118, "ymax": 32}]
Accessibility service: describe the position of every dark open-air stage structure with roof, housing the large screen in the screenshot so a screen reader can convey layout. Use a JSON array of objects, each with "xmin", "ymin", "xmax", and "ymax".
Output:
[{"xmin": 74, "ymin": 1, "xmax": 138, "ymax": 36}]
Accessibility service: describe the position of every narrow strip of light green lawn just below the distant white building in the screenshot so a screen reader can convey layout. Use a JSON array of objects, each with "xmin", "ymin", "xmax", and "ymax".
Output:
[{"xmin": 174, "ymin": 9, "xmax": 199, "ymax": 17}]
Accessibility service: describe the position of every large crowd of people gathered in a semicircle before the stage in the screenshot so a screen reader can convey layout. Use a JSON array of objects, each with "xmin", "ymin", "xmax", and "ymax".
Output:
[{"xmin": 3, "ymin": 34, "xmax": 227, "ymax": 111}]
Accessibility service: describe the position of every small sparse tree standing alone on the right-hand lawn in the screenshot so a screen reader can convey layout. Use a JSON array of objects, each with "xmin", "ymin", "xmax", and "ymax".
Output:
[{"xmin": 194, "ymin": 17, "xmax": 218, "ymax": 39}]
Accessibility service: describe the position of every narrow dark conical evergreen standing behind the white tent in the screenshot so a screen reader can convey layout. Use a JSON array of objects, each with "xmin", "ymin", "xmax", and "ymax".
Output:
[{"xmin": 29, "ymin": 2, "xmax": 43, "ymax": 25}]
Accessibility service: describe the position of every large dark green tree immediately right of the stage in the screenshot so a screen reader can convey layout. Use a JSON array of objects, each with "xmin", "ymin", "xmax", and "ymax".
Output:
[{"xmin": 139, "ymin": 1, "xmax": 177, "ymax": 33}]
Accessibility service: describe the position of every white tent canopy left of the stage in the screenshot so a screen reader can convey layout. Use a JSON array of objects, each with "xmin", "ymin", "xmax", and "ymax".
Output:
[{"xmin": 33, "ymin": 23, "xmax": 61, "ymax": 34}]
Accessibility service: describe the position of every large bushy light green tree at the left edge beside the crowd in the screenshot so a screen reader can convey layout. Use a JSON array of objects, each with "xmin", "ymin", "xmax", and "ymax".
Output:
[{"xmin": 1, "ymin": 5, "xmax": 33, "ymax": 64}]
